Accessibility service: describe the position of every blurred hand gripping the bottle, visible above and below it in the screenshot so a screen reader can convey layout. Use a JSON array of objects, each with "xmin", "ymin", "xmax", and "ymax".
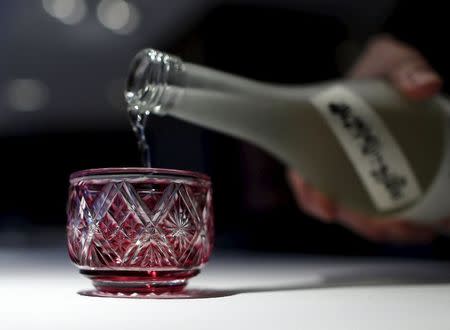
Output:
[{"xmin": 287, "ymin": 35, "xmax": 442, "ymax": 243}]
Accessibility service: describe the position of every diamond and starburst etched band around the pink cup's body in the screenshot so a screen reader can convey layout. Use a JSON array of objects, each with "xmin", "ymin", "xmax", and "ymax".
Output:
[{"xmin": 67, "ymin": 178, "xmax": 213, "ymax": 270}]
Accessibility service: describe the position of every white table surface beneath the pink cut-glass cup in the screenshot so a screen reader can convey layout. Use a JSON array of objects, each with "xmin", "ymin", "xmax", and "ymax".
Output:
[{"xmin": 0, "ymin": 249, "xmax": 450, "ymax": 330}]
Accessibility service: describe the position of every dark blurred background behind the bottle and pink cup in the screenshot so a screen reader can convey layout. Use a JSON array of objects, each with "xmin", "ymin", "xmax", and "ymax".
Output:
[{"xmin": 0, "ymin": 0, "xmax": 449, "ymax": 258}]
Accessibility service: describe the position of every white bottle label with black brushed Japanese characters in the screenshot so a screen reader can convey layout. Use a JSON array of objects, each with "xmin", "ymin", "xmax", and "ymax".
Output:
[{"xmin": 311, "ymin": 86, "xmax": 422, "ymax": 211}]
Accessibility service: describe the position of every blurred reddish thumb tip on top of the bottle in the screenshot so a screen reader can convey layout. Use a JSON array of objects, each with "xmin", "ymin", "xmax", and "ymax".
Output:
[{"xmin": 387, "ymin": 57, "xmax": 442, "ymax": 100}]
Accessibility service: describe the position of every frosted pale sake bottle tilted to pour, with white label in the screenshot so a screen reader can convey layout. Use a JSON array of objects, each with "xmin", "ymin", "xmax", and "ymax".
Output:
[{"xmin": 125, "ymin": 49, "xmax": 450, "ymax": 223}]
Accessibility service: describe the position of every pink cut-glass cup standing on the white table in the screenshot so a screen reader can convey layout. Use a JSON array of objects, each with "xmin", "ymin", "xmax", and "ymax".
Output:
[{"xmin": 67, "ymin": 168, "xmax": 213, "ymax": 295}]
